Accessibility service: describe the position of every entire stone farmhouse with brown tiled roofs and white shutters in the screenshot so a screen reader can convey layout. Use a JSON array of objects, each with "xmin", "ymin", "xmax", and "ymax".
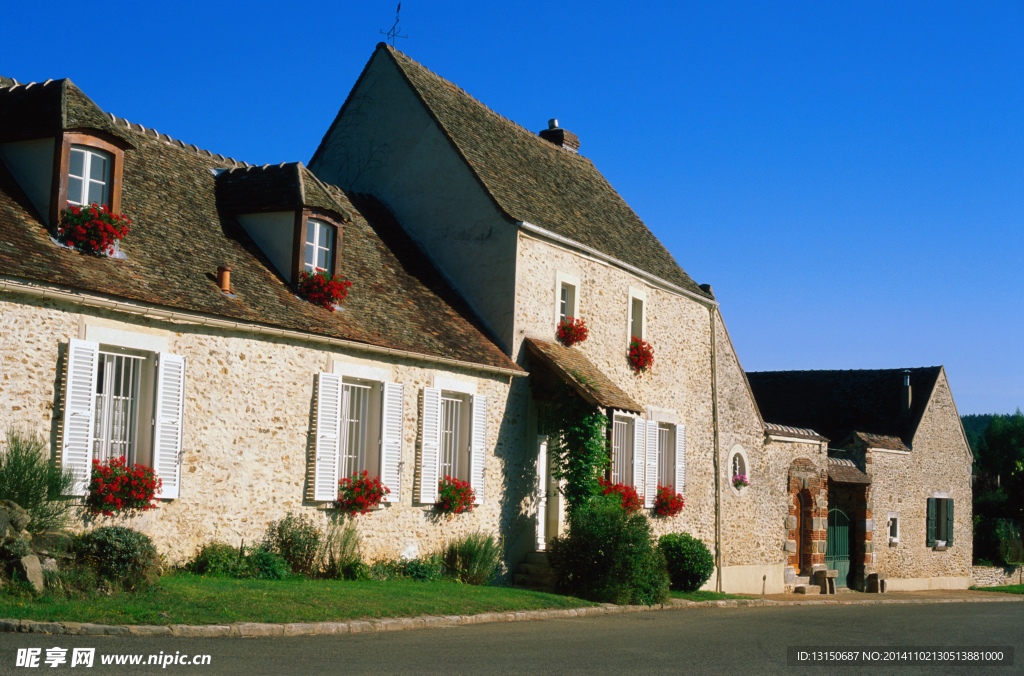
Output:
[{"xmin": 0, "ymin": 43, "xmax": 971, "ymax": 593}]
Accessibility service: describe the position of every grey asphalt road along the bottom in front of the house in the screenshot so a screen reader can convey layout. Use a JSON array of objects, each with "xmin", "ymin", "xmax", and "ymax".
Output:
[{"xmin": 0, "ymin": 603, "xmax": 1024, "ymax": 676}]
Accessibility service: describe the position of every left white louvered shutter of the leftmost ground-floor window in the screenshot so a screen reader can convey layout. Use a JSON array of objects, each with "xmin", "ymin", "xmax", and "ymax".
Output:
[{"xmin": 60, "ymin": 338, "xmax": 99, "ymax": 496}]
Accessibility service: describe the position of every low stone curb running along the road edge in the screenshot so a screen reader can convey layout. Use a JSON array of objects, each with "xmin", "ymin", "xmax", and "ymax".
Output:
[{"xmin": 0, "ymin": 597, "xmax": 1024, "ymax": 638}]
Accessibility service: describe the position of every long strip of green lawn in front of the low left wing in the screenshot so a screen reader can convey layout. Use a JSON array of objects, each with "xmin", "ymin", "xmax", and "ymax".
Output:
[{"xmin": 0, "ymin": 574, "xmax": 594, "ymax": 625}]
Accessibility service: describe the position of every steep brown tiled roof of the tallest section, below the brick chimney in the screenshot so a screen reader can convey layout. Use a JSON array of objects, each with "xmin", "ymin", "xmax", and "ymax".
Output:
[{"xmin": 310, "ymin": 43, "xmax": 713, "ymax": 298}]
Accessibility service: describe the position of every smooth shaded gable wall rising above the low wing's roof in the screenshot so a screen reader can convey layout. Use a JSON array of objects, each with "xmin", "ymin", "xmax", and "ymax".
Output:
[{"xmin": 310, "ymin": 50, "xmax": 516, "ymax": 349}]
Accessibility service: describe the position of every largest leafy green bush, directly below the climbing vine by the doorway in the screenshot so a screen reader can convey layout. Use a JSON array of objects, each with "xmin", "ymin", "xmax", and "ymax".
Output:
[{"xmin": 548, "ymin": 494, "xmax": 669, "ymax": 605}]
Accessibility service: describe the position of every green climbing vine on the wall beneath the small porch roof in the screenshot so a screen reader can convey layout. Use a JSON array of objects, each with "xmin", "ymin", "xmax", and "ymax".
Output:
[{"xmin": 544, "ymin": 384, "xmax": 610, "ymax": 514}]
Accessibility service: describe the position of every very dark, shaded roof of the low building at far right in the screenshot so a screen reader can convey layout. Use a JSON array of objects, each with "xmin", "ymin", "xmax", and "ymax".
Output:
[{"xmin": 746, "ymin": 367, "xmax": 942, "ymax": 443}]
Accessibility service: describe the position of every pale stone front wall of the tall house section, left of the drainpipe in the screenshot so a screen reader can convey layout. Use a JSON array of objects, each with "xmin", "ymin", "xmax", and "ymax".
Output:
[{"xmin": 513, "ymin": 233, "xmax": 715, "ymax": 551}]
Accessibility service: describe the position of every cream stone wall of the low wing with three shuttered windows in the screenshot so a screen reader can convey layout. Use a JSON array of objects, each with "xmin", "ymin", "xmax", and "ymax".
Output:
[{"xmin": 0, "ymin": 295, "xmax": 532, "ymax": 561}]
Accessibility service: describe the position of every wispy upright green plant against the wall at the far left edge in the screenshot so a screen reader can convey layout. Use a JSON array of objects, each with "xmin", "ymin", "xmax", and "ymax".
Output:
[{"xmin": 0, "ymin": 428, "xmax": 75, "ymax": 533}]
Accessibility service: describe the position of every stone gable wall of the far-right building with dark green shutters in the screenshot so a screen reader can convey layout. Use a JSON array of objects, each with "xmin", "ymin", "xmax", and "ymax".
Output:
[{"xmin": 868, "ymin": 372, "xmax": 973, "ymax": 580}]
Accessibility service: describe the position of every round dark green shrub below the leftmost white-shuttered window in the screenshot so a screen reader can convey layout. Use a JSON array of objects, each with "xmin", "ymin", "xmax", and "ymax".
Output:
[{"xmin": 75, "ymin": 525, "xmax": 160, "ymax": 591}]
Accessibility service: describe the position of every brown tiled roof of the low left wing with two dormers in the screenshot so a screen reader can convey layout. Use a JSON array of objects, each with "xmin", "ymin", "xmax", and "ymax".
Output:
[{"xmin": 0, "ymin": 83, "xmax": 522, "ymax": 373}]
